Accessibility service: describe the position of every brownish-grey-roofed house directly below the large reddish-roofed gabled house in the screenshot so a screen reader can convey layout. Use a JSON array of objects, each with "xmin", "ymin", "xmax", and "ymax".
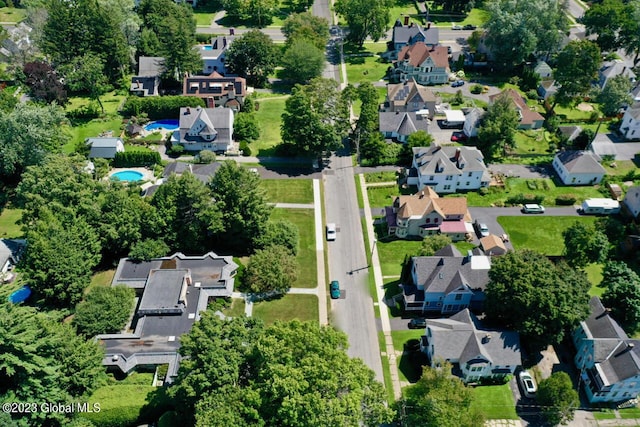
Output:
[{"xmin": 380, "ymin": 79, "xmax": 438, "ymax": 119}]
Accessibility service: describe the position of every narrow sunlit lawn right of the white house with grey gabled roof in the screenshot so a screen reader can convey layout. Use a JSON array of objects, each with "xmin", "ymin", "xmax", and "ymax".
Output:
[{"xmin": 249, "ymin": 97, "xmax": 286, "ymax": 156}]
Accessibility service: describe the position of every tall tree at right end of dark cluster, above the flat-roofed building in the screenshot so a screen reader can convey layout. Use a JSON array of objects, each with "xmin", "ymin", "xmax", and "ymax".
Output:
[{"xmin": 209, "ymin": 161, "xmax": 272, "ymax": 252}]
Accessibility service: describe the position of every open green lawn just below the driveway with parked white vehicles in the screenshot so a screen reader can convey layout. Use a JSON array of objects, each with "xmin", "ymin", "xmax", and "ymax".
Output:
[{"xmin": 498, "ymin": 215, "xmax": 597, "ymax": 255}]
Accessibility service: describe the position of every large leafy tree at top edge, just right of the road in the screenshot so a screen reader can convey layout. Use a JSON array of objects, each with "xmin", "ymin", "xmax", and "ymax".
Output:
[{"xmin": 335, "ymin": 0, "xmax": 391, "ymax": 47}]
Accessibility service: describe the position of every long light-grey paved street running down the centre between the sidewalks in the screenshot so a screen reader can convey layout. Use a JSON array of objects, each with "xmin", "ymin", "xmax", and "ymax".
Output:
[{"xmin": 324, "ymin": 151, "xmax": 384, "ymax": 382}]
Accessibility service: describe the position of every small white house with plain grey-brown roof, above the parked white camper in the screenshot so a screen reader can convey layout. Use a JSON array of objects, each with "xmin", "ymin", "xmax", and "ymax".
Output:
[{"xmin": 552, "ymin": 150, "xmax": 607, "ymax": 185}]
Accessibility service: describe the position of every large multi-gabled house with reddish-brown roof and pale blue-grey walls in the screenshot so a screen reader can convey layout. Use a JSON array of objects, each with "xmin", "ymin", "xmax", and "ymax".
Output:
[{"xmin": 391, "ymin": 42, "xmax": 451, "ymax": 85}]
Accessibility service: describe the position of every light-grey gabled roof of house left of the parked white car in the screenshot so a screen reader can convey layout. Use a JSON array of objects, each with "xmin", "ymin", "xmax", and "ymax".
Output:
[{"xmin": 427, "ymin": 309, "xmax": 522, "ymax": 366}]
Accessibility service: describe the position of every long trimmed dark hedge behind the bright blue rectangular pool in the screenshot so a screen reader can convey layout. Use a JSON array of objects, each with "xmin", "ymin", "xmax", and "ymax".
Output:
[{"xmin": 122, "ymin": 96, "xmax": 205, "ymax": 120}]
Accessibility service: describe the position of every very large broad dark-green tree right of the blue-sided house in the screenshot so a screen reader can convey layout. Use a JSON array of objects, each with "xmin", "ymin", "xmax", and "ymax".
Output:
[{"xmin": 485, "ymin": 250, "xmax": 590, "ymax": 347}]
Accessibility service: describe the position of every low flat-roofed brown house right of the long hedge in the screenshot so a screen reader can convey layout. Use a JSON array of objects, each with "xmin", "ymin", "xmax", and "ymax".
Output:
[{"xmin": 182, "ymin": 71, "xmax": 247, "ymax": 111}]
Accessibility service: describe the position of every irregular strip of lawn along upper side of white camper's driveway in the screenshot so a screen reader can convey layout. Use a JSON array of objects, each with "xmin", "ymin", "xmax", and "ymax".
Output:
[{"xmin": 452, "ymin": 178, "xmax": 603, "ymax": 206}]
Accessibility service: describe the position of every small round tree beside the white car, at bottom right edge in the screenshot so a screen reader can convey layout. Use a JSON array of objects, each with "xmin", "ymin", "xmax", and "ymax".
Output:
[{"xmin": 536, "ymin": 372, "xmax": 580, "ymax": 425}]
